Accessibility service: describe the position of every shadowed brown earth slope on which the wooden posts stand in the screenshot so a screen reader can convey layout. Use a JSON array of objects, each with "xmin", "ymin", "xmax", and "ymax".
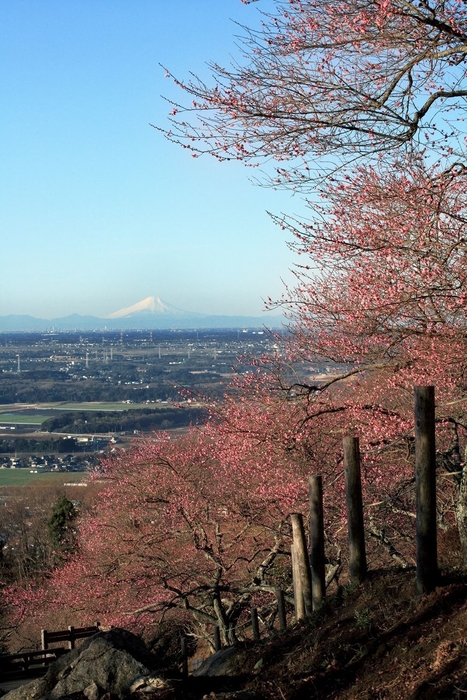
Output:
[{"xmin": 149, "ymin": 550, "xmax": 467, "ymax": 700}]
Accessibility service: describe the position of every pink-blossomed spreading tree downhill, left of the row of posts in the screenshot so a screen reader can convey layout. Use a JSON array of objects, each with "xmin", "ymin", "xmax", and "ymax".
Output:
[{"xmin": 7, "ymin": 431, "xmax": 302, "ymax": 644}]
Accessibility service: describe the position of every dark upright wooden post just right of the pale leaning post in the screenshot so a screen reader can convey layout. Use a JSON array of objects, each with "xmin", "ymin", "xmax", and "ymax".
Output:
[{"xmin": 308, "ymin": 474, "xmax": 326, "ymax": 610}]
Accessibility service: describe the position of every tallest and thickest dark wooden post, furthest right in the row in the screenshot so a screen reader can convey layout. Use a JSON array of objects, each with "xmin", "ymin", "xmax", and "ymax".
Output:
[{"xmin": 415, "ymin": 386, "xmax": 438, "ymax": 595}]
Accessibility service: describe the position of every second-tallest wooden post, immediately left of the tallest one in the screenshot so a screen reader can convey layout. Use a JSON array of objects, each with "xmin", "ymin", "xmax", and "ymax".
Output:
[{"xmin": 343, "ymin": 436, "xmax": 367, "ymax": 583}]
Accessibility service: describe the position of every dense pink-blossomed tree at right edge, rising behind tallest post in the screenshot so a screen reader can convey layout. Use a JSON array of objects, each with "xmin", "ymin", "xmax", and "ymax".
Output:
[{"xmin": 270, "ymin": 156, "xmax": 467, "ymax": 559}]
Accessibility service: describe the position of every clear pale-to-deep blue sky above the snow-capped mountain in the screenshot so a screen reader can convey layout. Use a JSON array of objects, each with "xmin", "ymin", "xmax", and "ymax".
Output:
[{"xmin": 0, "ymin": 0, "xmax": 300, "ymax": 318}]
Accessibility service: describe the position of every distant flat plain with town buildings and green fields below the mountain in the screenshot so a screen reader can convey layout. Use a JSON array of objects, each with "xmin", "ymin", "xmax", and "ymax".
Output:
[{"xmin": 0, "ymin": 328, "xmax": 292, "ymax": 473}]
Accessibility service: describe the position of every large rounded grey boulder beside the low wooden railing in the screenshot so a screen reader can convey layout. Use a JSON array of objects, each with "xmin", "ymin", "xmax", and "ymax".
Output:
[{"xmin": 3, "ymin": 628, "xmax": 159, "ymax": 700}]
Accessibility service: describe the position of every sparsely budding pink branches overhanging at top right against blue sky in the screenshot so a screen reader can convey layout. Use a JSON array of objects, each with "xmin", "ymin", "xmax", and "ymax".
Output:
[{"xmin": 160, "ymin": 0, "xmax": 467, "ymax": 188}]
